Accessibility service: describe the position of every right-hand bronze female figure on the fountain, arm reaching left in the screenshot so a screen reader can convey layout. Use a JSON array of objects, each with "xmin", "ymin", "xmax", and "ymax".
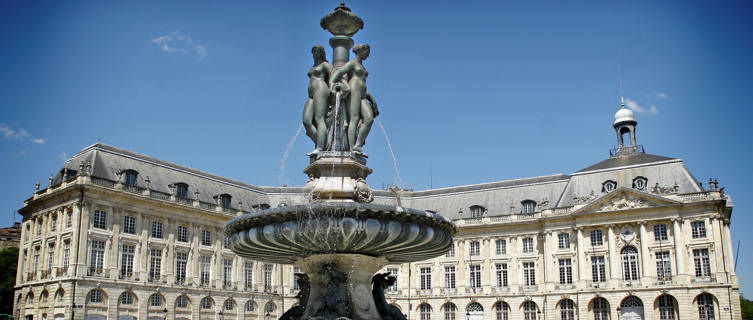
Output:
[{"xmin": 330, "ymin": 44, "xmax": 378, "ymax": 153}]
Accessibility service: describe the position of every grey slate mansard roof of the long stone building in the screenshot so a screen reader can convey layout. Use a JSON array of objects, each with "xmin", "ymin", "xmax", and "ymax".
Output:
[{"xmin": 35, "ymin": 143, "xmax": 702, "ymax": 219}]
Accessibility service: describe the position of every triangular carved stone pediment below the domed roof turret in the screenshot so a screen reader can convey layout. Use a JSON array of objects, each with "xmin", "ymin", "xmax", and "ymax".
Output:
[{"xmin": 574, "ymin": 187, "xmax": 679, "ymax": 213}]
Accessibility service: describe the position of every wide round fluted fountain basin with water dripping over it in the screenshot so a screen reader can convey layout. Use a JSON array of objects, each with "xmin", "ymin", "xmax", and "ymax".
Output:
[{"xmin": 226, "ymin": 202, "xmax": 457, "ymax": 264}]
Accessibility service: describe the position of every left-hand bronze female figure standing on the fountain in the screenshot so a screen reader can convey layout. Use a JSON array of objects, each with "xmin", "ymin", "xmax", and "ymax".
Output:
[{"xmin": 303, "ymin": 45, "xmax": 332, "ymax": 154}]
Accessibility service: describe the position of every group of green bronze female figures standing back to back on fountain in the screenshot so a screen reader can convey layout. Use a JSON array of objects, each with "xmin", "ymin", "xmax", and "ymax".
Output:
[{"xmin": 303, "ymin": 44, "xmax": 379, "ymax": 155}]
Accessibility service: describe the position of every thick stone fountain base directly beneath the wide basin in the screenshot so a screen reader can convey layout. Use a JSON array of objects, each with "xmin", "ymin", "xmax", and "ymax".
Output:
[{"xmin": 296, "ymin": 254, "xmax": 388, "ymax": 320}]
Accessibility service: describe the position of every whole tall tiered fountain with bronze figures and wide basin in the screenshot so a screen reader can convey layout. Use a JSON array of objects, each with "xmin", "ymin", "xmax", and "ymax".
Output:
[{"xmin": 226, "ymin": 4, "xmax": 457, "ymax": 320}]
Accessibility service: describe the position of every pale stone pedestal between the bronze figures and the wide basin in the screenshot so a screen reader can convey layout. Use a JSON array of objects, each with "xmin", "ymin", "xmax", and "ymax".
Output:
[{"xmin": 303, "ymin": 151, "xmax": 374, "ymax": 202}]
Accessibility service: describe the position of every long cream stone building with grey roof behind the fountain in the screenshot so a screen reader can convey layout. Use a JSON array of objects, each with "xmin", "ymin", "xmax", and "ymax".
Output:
[{"xmin": 14, "ymin": 106, "xmax": 740, "ymax": 320}]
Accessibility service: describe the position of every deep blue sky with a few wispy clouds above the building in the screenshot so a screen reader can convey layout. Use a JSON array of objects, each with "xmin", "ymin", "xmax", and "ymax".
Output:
[{"xmin": 0, "ymin": 0, "xmax": 753, "ymax": 292}]
